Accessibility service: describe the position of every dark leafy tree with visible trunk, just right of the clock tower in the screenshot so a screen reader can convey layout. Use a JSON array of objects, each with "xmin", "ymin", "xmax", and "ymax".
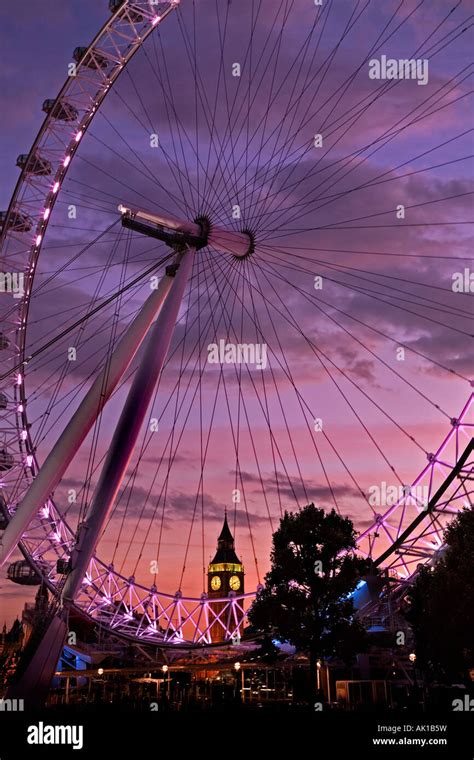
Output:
[{"xmin": 249, "ymin": 504, "xmax": 369, "ymax": 698}]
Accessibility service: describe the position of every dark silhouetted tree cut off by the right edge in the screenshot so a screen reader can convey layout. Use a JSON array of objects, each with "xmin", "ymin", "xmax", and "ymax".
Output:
[{"xmin": 405, "ymin": 508, "xmax": 474, "ymax": 683}]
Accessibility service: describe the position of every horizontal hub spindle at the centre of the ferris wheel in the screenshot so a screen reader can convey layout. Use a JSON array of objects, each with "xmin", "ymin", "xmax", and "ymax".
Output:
[{"xmin": 118, "ymin": 205, "xmax": 255, "ymax": 259}]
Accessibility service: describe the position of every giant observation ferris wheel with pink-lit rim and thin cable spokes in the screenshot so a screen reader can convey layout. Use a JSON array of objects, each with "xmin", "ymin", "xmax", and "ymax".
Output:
[{"xmin": 0, "ymin": 0, "xmax": 474, "ymax": 646}]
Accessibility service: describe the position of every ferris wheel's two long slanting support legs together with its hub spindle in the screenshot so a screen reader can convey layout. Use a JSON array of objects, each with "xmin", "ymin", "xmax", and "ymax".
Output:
[{"xmin": 0, "ymin": 200, "xmax": 254, "ymax": 701}]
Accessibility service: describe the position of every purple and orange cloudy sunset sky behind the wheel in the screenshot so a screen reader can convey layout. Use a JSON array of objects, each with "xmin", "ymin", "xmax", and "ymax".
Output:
[{"xmin": 0, "ymin": 0, "xmax": 472, "ymax": 628}]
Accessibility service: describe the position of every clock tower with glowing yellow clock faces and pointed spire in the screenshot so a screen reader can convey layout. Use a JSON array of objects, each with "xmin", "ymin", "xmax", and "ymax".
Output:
[{"xmin": 207, "ymin": 513, "xmax": 244, "ymax": 643}]
